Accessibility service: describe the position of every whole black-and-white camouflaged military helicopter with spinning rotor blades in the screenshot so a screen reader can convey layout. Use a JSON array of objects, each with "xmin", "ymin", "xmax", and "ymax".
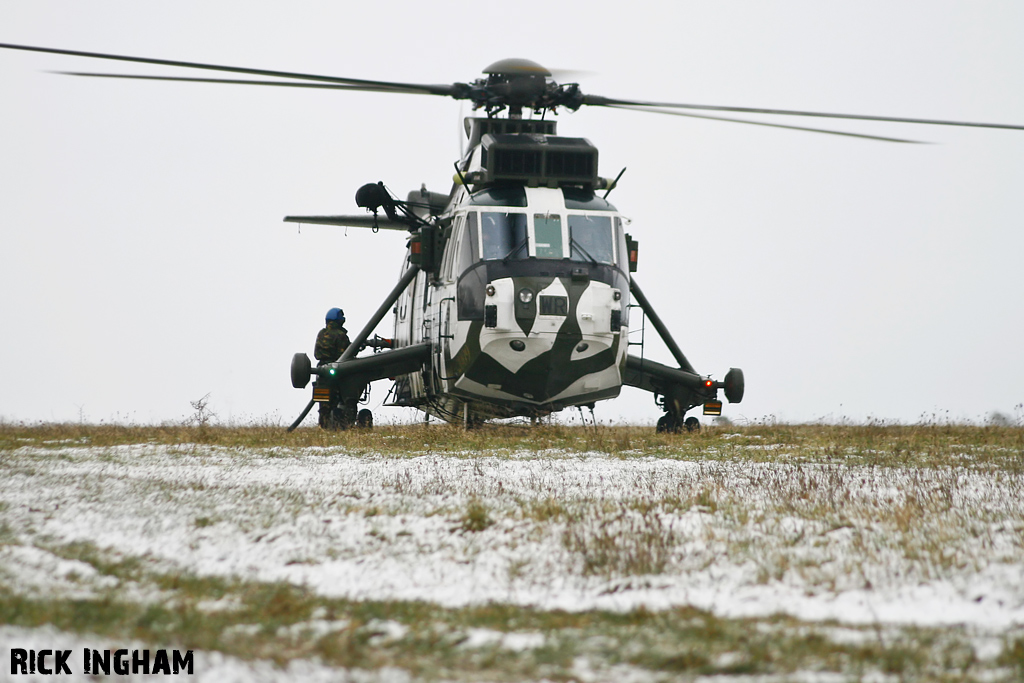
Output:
[{"xmin": 0, "ymin": 44, "xmax": 1024, "ymax": 432}]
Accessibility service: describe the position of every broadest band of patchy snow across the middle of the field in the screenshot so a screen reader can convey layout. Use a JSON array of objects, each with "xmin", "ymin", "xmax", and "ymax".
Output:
[{"xmin": 0, "ymin": 445, "xmax": 1024, "ymax": 631}]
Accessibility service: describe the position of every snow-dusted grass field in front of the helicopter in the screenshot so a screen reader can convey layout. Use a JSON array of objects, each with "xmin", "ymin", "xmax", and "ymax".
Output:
[{"xmin": 0, "ymin": 424, "xmax": 1024, "ymax": 681}]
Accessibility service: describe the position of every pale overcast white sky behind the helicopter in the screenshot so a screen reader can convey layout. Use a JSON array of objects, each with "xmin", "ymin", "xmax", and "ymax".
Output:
[{"xmin": 0, "ymin": 0, "xmax": 1024, "ymax": 422}]
